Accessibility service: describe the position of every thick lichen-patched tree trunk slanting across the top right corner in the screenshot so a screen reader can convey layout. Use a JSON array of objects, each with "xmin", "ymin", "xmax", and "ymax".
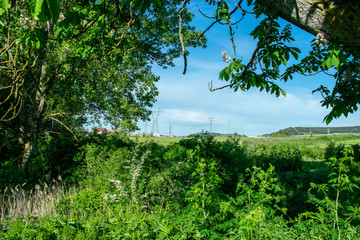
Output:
[{"xmin": 262, "ymin": 0, "xmax": 360, "ymax": 47}]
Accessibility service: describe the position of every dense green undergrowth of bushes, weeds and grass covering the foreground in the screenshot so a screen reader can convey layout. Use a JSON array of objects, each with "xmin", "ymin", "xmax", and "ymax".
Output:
[{"xmin": 0, "ymin": 134, "xmax": 360, "ymax": 239}]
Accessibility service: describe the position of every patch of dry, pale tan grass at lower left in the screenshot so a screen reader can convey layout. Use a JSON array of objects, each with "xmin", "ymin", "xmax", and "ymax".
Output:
[{"xmin": 0, "ymin": 176, "xmax": 71, "ymax": 220}]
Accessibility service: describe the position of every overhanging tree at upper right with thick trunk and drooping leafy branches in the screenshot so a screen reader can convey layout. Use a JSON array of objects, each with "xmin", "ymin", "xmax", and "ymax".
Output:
[{"xmin": 198, "ymin": 0, "xmax": 360, "ymax": 124}]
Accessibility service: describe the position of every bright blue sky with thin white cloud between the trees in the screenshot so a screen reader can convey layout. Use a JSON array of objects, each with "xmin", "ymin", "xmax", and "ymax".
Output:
[{"xmin": 139, "ymin": 1, "xmax": 360, "ymax": 136}]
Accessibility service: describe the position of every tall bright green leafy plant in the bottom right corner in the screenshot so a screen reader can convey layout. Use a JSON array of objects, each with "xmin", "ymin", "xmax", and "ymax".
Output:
[{"xmin": 299, "ymin": 147, "xmax": 360, "ymax": 239}]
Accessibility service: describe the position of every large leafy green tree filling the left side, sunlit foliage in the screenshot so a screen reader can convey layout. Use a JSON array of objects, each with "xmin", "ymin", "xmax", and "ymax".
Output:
[{"xmin": 0, "ymin": 0, "xmax": 204, "ymax": 176}]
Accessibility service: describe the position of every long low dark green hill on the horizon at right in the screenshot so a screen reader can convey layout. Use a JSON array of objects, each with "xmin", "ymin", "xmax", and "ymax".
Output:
[{"xmin": 265, "ymin": 126, "xmax": 360, "ymax": 136}]
